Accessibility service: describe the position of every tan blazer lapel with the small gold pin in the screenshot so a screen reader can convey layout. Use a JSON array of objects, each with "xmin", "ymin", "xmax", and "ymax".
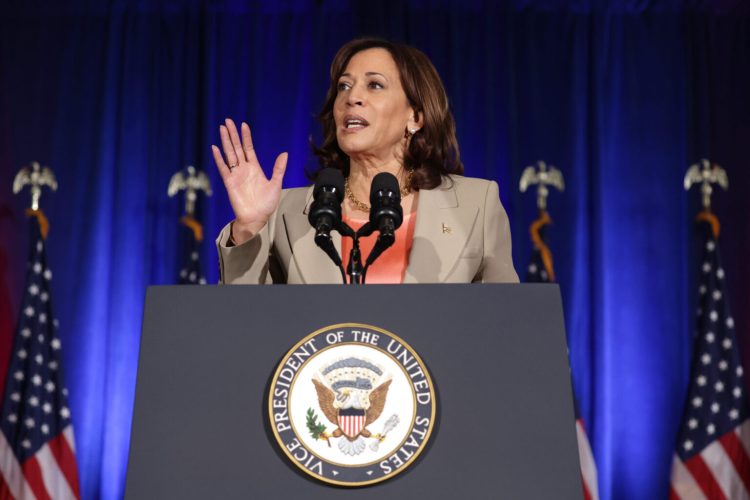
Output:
[{"xmin": 404, "ymin": 180, "xmax": 478, "ymax": 283}]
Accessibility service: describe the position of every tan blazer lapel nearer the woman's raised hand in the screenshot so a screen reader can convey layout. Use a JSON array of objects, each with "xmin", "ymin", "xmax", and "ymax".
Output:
[{"xmin": 283, "ymin": 187, "xmax": 341, "ymax": 284}]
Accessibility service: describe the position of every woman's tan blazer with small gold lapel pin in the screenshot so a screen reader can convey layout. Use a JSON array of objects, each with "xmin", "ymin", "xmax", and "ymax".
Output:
[{"xmin": 216, "ymin": 176, "xmax": 518, "ymax": 284}]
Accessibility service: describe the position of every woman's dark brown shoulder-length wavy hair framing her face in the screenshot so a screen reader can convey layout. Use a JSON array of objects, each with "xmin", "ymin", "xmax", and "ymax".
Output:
[{"xmin": 312, "ymin": 38, "xmax": 464, "ymax": 190}]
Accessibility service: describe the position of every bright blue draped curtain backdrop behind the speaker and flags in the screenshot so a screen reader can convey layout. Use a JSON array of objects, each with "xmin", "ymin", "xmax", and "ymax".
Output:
[{"xmin": 0, "ymin": 0, "xmax": 750, "ymax": 499}]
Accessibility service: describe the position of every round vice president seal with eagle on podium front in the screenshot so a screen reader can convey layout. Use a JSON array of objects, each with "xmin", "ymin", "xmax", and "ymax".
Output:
[{"xmin": 268, "ymin": 323, "xmax": 435, "ymax": 486}]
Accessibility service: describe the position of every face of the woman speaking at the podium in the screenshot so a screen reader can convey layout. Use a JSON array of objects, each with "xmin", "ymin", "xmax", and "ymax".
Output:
[{"xmin": 333, "ymin": 48, "xmax": 415, "ymax": 162}]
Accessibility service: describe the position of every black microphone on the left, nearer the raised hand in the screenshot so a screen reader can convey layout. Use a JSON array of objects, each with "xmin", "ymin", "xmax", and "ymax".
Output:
[{"xmin": 307, "ymin": 168, "xmax": 344, "ymax": 267}]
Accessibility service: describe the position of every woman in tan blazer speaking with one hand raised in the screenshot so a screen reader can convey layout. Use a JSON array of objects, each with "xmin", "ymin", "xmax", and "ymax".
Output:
[{"xmin": 212, "ymin": 39, "xmax": 518, "ymax": 284}]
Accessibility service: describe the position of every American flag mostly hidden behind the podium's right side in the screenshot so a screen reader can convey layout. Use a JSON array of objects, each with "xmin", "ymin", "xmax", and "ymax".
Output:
[{"xmin": 526, "ymin": 213, "xmax": 599, "ymax": 500}]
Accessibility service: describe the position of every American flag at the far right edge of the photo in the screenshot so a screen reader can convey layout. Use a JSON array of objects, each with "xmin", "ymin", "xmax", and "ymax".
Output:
[{"xmin": 670, "ymin": 224, "xmax": 750, "ymax": 499}]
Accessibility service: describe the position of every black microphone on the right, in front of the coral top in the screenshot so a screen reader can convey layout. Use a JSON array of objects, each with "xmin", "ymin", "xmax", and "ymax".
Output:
[{"xmin": 365, "ymin": 172, "xmax": 404, "ymax": 267}]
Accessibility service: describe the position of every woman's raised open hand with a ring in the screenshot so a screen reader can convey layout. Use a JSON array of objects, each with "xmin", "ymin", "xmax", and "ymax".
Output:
[{"xmin": 211, "ymin": 118, "xmax": 289, "ymax": 244}]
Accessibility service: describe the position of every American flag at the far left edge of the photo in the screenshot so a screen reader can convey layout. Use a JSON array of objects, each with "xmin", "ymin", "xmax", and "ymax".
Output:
[{"xmin": 0, "ymin": 217, "xmax": 80, "ymax": 500}]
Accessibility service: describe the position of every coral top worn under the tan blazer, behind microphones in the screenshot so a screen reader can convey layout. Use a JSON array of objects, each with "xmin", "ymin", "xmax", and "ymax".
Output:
[{"xmin": 341, "ymin": 211, "xmax": 417, "ymax": 284}]
